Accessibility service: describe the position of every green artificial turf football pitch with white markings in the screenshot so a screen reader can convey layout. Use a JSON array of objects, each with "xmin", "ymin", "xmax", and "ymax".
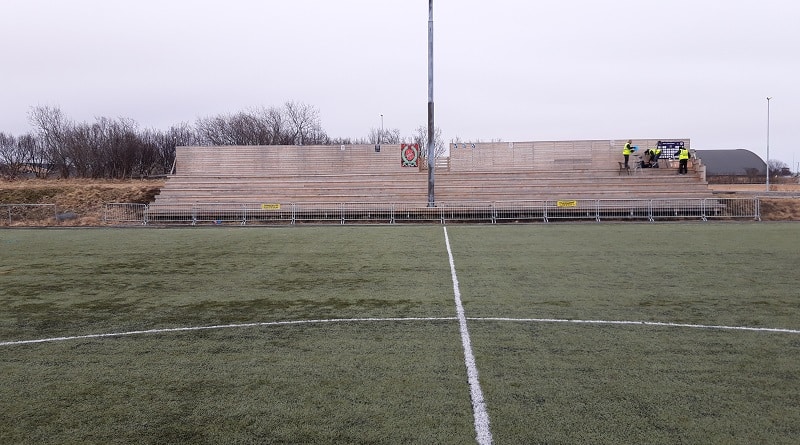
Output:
[{"xmin": 0, "ymin": 223, "xmax": 800, "ymax": 444}]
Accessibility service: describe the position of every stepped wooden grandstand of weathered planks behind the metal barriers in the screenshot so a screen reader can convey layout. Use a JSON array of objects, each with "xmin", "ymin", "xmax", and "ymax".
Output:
[{"xmin": 153, "ymin": 139, "xmax": 712, "ymax": 208}]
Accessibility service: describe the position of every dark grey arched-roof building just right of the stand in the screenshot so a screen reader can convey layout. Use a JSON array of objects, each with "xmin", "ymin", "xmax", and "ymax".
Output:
[{"xmin": 695, "ymin": 148, "xmax": 767, "ymax": 184}]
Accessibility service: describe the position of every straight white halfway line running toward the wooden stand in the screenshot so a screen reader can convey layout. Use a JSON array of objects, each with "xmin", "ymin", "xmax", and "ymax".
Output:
[{"xmin": 444, "ymin": 227, "xmax": 492, "ymax": 445}]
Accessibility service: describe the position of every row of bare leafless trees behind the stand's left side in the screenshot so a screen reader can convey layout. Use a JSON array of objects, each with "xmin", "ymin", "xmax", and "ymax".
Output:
[{"xmin": 0, "ymin": 102, "xmax": 444, "ymax": 179}]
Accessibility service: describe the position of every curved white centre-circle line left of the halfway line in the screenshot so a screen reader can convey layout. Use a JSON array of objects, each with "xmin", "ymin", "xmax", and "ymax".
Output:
[{"xmin": 0, "ymin": 317, "xmax": 456, "ymax": 346}]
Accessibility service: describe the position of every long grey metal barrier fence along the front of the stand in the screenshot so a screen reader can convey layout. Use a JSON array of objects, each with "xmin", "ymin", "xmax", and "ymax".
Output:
[{"xmin": 103, "ymin": 198, "xmax": 761, "ymax": 225}]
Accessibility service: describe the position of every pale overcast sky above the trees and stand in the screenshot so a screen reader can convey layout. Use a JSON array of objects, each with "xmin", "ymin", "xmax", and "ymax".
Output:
[{"xmin": 0, "ymin": 0, "xmax": 800, "ymax": 166}]
